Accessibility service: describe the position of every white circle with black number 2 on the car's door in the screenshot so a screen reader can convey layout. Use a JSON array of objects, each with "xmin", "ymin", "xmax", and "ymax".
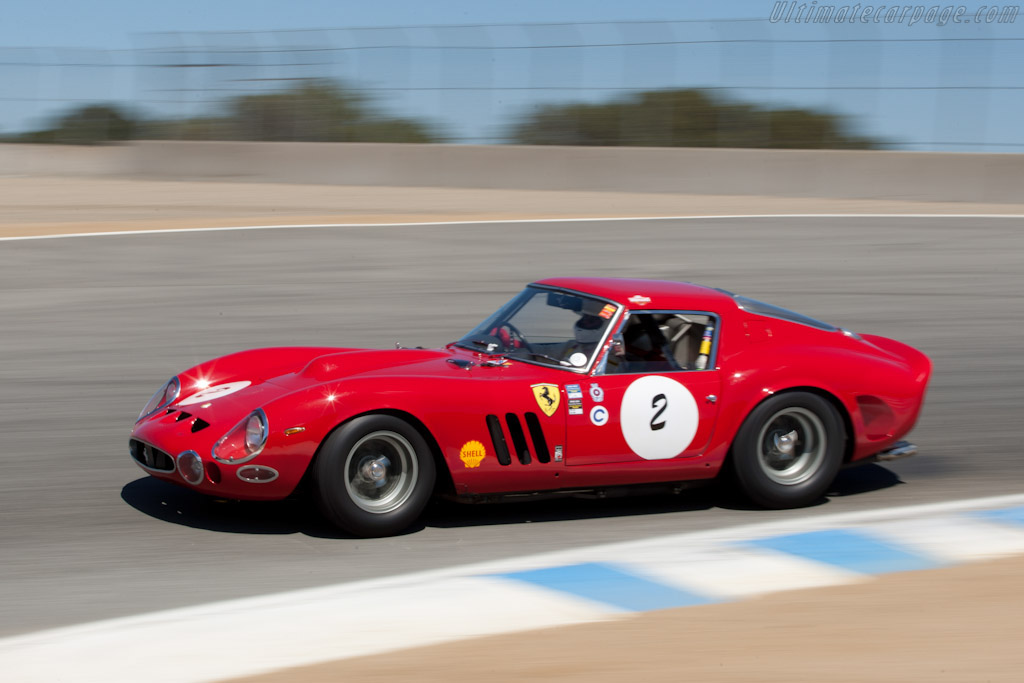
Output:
[{"xmin": 618, "ymin": 375, "xmax": 699, "ymax": 460}]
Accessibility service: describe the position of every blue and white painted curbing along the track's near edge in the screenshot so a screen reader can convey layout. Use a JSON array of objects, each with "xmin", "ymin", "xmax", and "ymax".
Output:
[{"xmin": 6, "ymin": 495, "xmax": 1024, "ymax": 683}]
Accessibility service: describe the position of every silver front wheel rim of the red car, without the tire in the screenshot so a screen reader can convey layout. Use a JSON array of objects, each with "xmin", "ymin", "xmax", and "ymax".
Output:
[{"xmin": 345, "ymin": 431, "xmax": 419, "ymax": 514}]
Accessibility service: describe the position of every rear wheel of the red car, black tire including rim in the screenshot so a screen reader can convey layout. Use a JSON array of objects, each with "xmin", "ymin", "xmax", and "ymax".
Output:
[{"xmin": 731, "ymin": 391, "xmax": 845, "ymax": 509}]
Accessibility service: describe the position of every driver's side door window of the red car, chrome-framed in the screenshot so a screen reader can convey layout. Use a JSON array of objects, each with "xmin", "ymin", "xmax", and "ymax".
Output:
[{"xmin": 605, "ymin": 312, "xmax": 716, "ymax": 375}]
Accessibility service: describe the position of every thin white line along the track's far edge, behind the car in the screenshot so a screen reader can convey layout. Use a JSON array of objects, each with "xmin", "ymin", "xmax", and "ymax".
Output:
[{"xmin": 0, "ymin": 213, "xmax": 1024, "ymax": 242}]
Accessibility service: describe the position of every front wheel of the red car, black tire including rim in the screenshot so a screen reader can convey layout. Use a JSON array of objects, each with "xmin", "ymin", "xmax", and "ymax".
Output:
[{"xmin": 313, "ymin": 415, "xmax": 436, "ymax": 538}]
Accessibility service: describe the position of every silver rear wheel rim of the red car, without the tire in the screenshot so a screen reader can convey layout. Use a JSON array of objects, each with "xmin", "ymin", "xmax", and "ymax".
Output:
[{"xmin": 758, "ymin": 407, "xmax": 827, "ymax": 486}]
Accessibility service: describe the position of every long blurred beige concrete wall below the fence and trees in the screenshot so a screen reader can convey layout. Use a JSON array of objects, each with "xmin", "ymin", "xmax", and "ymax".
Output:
[{"xmin": 0, "ymin": 141, "xmax": 1024, "ymax": 203}]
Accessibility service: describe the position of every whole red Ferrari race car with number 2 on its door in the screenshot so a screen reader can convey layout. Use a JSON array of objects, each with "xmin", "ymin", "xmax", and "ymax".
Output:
[{"xmin": 130, "ymin": 278, "xmax": 931, "ymax": 536}]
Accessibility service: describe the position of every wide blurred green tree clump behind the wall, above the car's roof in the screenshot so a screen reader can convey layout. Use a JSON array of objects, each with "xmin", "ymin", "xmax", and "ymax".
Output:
[{"xmin": 510, "ymin": 89, "xmax": 878, "ymax": 150}]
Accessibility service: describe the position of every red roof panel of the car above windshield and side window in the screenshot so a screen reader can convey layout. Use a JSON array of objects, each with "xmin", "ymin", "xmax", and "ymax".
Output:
[{"xmin": 534, "ymin": 278, "xmax": 737, "ymax": 311}]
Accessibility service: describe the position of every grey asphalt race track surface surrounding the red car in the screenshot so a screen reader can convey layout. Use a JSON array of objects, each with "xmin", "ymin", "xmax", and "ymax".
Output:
[{"xmin": 0, "ymin": 217, "xmax": 1024, "ymax": 636}]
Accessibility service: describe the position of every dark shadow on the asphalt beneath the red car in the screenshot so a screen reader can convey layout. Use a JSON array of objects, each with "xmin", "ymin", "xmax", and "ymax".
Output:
[{"xmin": 121, "ymin": 465, "xmax": 903, "ymax": 539}]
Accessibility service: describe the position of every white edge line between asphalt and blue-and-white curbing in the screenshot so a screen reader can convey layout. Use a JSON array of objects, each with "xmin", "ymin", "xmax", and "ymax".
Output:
[{"xmin": 0, "ymin": 494, "xmax": 1024, "ymax": 648}]
